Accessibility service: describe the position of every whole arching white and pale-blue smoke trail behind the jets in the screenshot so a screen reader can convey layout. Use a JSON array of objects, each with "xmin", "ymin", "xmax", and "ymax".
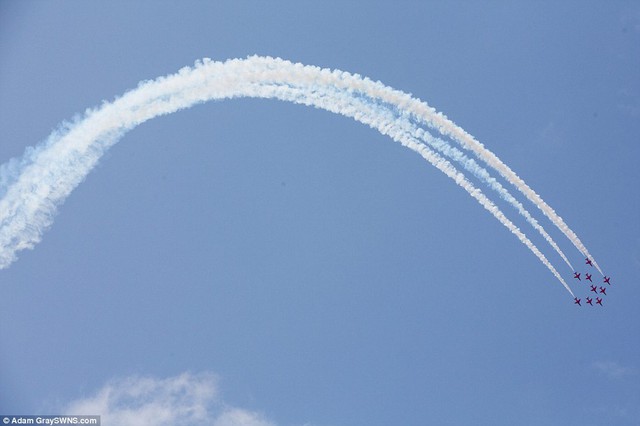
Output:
[{"xmin": 0, "ymin": 56, "xmax": 595, "ymax": 293}]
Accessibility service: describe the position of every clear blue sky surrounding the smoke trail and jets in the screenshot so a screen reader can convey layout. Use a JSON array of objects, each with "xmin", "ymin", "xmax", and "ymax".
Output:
[{"xmin": 0, "ymin": 0, "xmax": 640, "ymax": 425}]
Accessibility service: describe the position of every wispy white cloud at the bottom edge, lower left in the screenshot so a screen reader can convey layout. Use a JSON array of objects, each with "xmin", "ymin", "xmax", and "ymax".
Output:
[{"xmin": 64, "ymin": 373, "xmax": 275, "ymax": 426}]
